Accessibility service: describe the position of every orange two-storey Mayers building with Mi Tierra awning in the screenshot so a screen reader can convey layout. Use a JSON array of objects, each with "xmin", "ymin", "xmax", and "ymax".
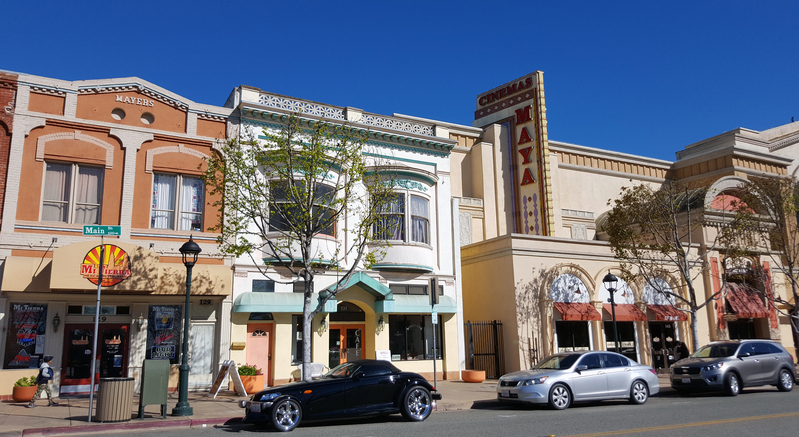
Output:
[{"xmin": 0, "ymin": 74, "xmax": 232, "ymax": 396}]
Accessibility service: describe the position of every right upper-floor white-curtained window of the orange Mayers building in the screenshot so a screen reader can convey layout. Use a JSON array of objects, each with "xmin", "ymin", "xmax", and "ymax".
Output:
[{"xmin": 150, "ymin": 173, "xmax": 205, "ymax": 231}]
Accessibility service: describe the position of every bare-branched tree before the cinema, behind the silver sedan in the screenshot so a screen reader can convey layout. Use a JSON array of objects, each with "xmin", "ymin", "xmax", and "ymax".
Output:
[{"xmin": 602, "ymin": 181, "xmax": 722, "ymax": 347}]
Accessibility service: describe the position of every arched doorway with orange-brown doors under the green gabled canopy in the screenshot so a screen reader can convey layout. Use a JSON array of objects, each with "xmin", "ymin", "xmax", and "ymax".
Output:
[{"xmin": 328, "ymin": 302, "xmax": 366, "ymax": 369}]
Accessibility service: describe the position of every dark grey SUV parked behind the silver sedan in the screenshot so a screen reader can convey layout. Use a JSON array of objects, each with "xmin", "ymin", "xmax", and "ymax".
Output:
[{"xmin": 671, "ymin": 340, "xmax": 796, "ymax": 396}]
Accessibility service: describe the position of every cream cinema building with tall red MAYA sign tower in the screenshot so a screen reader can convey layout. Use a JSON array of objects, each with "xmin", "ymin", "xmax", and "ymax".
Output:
[{"xmin": 452, "ymin": 72, "xmax": 799, "ymax": 374}]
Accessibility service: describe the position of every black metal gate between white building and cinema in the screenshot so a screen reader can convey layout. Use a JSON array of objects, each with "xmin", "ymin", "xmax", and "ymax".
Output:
[{"xmin": 464, "ymin": 320, "xmax": 505, "ymax": 379}]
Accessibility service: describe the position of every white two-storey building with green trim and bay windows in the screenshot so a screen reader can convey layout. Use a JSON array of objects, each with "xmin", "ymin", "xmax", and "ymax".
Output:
[{"xmin": 222, "ymin": 86, "xmax": 463, "ymax": 385}]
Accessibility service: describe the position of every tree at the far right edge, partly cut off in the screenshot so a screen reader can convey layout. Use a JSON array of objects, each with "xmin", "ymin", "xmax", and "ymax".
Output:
[{"xmin": 726, "ymin": 176, "xmax": 799, "ymax": 351}]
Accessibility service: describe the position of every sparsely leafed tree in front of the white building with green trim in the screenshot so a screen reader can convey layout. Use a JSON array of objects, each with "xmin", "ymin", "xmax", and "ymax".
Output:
[{"xmin": 205, "ymin": 114, "xmax": 394, "ymax": 380}]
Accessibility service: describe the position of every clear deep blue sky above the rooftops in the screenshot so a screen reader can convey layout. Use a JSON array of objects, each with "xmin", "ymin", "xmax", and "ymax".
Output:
[{"xmin": 0, "ymin": 0, "xmax": 799, "ymax": 160}]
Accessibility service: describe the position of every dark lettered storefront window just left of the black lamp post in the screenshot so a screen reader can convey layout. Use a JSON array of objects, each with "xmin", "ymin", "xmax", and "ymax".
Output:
[{"xmin": 145, "ymin": 305, "xmax": 183, "ymax": 364}]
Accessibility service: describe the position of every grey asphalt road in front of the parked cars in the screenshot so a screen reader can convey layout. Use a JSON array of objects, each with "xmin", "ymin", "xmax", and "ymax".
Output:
[{"xmin": 108, "ymin": 388, "xmax": 799, "ymax": 437}]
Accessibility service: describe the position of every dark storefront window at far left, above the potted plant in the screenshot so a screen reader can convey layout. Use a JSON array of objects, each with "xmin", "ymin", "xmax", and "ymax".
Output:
[{"xmin": 3, "ymin": 303, "xmax": 47, "ymax": 369}]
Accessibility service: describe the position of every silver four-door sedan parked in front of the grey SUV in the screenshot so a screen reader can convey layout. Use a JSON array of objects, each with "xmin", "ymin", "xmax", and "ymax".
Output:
[{"xmin": 497, "ymin": 351, "xmax": 660, "ymax": 410}]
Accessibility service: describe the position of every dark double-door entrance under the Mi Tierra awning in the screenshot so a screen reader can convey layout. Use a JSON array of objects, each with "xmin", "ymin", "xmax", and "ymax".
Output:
[{"xmin": 61, "ymin": 323, "xmax": 130, "ymax": 393}]
